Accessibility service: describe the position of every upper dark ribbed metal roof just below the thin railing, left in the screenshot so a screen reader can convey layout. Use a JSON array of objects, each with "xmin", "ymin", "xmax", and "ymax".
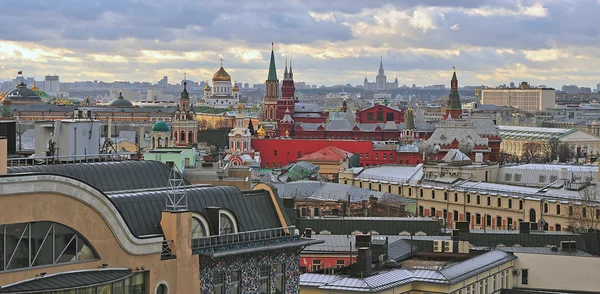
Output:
[{"xmin": 8, "ymin": 160, "xmax": 189, "ymax": 192}]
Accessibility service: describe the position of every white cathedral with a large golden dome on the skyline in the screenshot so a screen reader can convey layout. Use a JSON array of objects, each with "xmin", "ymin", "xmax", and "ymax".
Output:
[{"xmin": 204, "ymin": 60, "xmax": 240, "ymax": 108}]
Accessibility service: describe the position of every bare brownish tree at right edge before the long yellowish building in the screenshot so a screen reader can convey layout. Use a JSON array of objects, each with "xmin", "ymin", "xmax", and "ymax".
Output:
[{"xmin": 569, "ymin": 185, "xmax": 600, "ymax": 231}]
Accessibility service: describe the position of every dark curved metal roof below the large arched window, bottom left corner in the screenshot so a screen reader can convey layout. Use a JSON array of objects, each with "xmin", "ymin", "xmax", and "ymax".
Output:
[{"xmin": 0, "ymin": 269, "xmax": 132, "ymax": 293}]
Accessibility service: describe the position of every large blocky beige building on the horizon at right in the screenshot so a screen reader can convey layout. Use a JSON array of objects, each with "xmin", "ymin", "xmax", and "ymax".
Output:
[{"xmin": 481, "ymin": 82, "xmax": 556, "ymax": 113}]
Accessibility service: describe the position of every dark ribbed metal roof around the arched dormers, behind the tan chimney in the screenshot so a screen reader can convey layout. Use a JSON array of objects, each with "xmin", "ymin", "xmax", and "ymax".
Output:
[{"xmin": 108, "ymin": 186, "xmax": 287, "ymax": 237}]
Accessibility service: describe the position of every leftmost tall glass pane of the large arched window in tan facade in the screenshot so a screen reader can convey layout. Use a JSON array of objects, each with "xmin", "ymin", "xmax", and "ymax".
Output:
[{"xmin": 6, "ymin": 224, "xmax": 29, "ymax": 269}]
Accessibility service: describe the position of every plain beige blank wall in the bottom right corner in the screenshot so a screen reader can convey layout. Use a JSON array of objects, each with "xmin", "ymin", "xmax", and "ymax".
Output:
[{"xmin": 513, "ymin": 253, "xmax": 600, "ymax": 291}]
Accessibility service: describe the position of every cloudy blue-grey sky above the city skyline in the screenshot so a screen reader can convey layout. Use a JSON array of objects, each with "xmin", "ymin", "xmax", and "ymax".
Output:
[{"xmin": 0, "ymin": 0, "xmax": 600, "ymax": 88}]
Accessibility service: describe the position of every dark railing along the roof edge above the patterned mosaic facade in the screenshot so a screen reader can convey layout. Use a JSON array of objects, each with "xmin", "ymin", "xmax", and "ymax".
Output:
[{"xmin": 192, "ymin": 226, "xmax": 297, "ymax": 250}]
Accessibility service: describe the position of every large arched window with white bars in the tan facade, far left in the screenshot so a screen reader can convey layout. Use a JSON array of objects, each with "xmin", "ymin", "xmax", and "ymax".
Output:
[{"xmin": 0, "ymin": 221, "xmax": 98, "ymax": 272}]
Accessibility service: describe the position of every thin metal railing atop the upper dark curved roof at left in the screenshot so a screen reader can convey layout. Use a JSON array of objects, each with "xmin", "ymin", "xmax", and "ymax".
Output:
[{"xmin": 7, "ymin": 153, "xmax": 131, "ymax": 167}]
